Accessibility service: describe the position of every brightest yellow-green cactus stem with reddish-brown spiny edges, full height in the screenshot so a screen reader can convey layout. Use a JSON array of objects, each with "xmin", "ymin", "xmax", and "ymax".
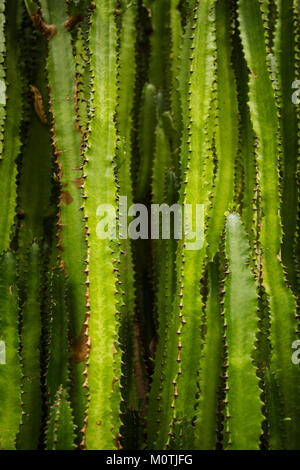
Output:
[{"xmin": 84, "ymin": 0, "xmax": 121, "ymax": 449}]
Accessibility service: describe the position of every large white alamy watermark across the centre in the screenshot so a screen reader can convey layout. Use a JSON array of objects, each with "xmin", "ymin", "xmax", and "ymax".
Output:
[{"xmin": 96, "ymin": 196, "xmax": 204, "ymax": 250}]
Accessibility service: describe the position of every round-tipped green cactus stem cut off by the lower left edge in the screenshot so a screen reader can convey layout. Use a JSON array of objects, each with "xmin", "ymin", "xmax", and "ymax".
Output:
[{"xmin": 0, "ymin": 252, "xmax": 22, "ymax": 450}]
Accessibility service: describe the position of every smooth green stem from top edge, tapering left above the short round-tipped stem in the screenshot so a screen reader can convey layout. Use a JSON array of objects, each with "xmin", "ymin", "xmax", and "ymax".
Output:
[{"xmin": 207, "ymin": 0, "xmax": 238, "ymax": 260}]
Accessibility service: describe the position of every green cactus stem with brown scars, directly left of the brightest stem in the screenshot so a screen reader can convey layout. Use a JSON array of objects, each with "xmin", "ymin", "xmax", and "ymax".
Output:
[{"xmin": 41, "ymin": 0, "xmax": 88, "ymax": 440}]
